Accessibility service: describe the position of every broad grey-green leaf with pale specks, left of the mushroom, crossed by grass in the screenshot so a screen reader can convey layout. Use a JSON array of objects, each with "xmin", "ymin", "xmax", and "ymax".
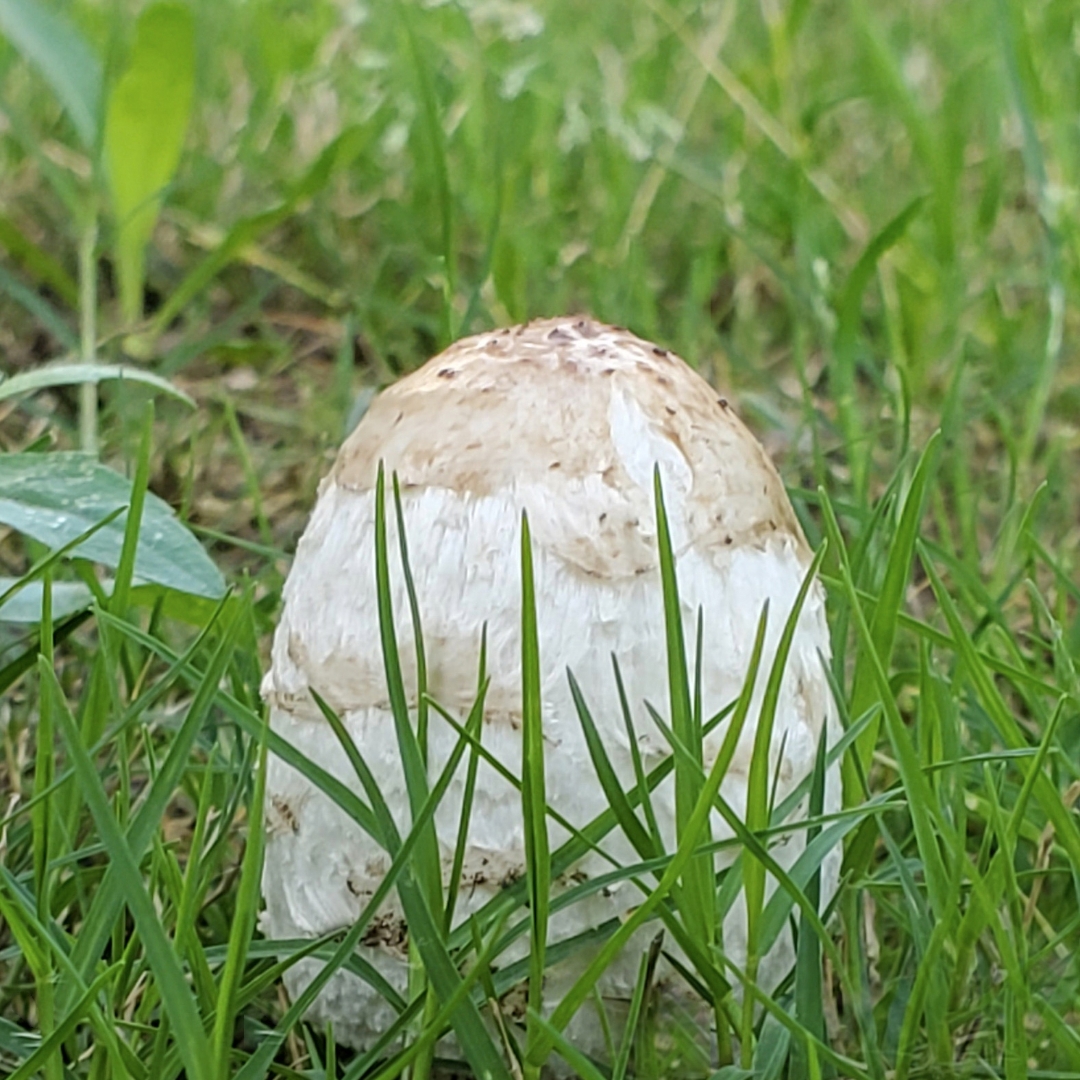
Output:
[{"xmin": 0, "ymin": 453, "xmax": 225, "ymax": 598}]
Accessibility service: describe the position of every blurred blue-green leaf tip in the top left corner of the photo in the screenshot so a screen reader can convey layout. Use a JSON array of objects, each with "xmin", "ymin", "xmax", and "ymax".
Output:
[{"xmin": 0, "ymin": 0, "xmax": 102, "ymax": 149}]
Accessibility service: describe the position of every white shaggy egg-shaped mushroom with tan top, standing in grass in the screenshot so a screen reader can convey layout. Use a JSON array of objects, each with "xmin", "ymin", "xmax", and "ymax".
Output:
[{"xmin": 262, "ymin": 318, "xmax": 840, "ymax": 1052}]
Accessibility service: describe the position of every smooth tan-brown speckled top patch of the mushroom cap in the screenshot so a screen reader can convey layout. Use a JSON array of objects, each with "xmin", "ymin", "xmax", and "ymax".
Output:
[{"xmin": 332, "ymin": 318, "xmax": 807, "ymax": 577}]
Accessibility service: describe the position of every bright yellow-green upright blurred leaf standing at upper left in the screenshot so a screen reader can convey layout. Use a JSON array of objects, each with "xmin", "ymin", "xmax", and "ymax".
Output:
[{"xmin": 105, "ymin": 3, "xmax": 195, "ymax": 322}]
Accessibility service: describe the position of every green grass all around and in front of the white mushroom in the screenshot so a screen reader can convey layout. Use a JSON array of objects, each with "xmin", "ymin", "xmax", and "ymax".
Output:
[{"xmin": 0, "ymin": 0, "xmax": 1080, "ymax": 1080}]
